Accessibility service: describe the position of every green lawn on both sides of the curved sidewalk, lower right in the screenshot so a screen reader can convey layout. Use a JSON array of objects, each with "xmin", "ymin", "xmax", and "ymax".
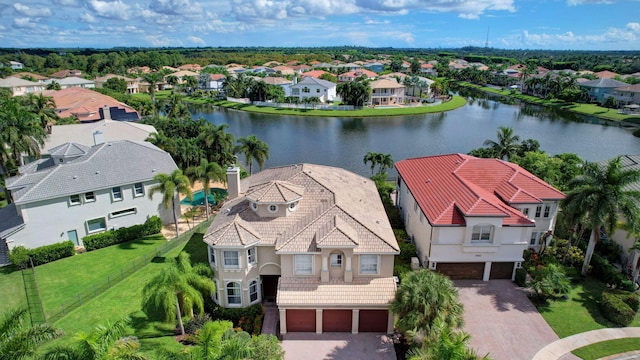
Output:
[{"xmin": 538, "ymin": 278, "xmax": 640, "ymax": 359}]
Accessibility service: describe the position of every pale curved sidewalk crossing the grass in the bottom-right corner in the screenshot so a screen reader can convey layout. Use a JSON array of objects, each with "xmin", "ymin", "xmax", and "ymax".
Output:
[{"xmin": 532, "ymin": 327, "xmax": 640, "ymax": 360}]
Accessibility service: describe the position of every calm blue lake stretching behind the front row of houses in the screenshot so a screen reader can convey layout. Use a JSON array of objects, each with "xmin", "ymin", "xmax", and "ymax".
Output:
[{"xmin": 193, "ymin": 98, "xmax": 640, "ymax": 175}]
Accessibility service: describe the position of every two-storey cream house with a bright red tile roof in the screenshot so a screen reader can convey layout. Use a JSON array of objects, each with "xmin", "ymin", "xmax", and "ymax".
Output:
[{"xmin": 395, "ymin": 154, "xmax": 565, "ymax": 281}]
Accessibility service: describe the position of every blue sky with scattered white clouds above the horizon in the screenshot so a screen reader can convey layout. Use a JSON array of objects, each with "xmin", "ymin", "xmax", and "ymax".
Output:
[{"xmin": 0, "ymin": 0, "xmax": 640, "ymax": 50}]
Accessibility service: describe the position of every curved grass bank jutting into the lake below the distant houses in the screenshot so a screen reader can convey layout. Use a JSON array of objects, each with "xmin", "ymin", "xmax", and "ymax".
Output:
[{"xmin": 212, "ymin": 96, "xmax": 467, "ymax": 117}]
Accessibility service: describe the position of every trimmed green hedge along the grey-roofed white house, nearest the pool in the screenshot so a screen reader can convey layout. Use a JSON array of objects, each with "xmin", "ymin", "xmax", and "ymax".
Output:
[{"xmin": 82, "ymin": 215, "xmax": 162, "ymax": 251}]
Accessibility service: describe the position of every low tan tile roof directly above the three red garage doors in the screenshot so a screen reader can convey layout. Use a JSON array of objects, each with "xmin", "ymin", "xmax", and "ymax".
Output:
[{"xmin": 276, "ymin": 277, "xmax": 396, "ymax": 307}]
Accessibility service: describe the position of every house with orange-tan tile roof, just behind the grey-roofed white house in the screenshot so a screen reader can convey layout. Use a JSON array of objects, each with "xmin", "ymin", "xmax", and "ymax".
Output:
[{"xmin": 43, "ymin": 87, "xmax": 140, "ymax": 122}]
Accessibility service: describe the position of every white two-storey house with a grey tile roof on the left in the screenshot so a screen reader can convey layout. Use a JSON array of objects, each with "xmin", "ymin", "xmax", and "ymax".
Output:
[{"xmin": 0, "ymin": 140, "xmax": 179, "ymax": 256}]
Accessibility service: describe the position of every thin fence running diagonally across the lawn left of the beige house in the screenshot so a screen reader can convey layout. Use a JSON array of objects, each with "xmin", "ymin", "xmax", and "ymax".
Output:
[{"xmin": 43, "ymin": 218, "xmax": 213, "ymax": 324}]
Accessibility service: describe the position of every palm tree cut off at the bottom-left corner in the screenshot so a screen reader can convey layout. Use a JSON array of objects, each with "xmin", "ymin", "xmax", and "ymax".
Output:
[{"xmin": 0, "ymin": 308, "xmax": 63, "ymax": 360}]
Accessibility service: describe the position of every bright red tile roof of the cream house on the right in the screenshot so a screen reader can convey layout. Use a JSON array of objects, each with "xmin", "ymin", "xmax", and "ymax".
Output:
[{"xmin": 395, "ymin": 154, "xmax": 564, "ymax": 226}]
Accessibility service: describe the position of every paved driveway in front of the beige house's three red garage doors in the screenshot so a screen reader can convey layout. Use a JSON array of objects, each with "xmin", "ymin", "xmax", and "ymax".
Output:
[{"xmin": 281, "ymin": 333, "xmax": 396, "ymax": 360}]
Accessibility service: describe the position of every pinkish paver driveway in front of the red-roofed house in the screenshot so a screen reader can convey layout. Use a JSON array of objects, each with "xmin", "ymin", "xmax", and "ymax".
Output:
[{"xmin": 454, "ymin": 280, "xmax": 579, "ymax": 360}]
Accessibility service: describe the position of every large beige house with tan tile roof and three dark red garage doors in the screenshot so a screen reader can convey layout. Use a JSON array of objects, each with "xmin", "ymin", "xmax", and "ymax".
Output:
[{"xmin": 203, "ymin": 164, "xmax": 399, "ymax": 334}]
